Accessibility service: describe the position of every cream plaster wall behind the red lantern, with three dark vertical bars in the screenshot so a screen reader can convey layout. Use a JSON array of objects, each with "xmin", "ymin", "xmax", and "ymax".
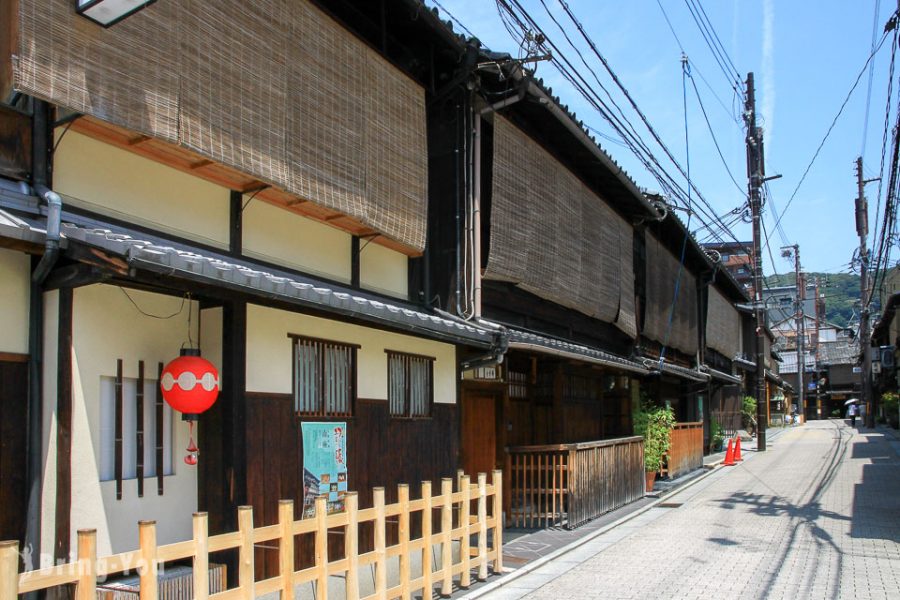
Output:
[{"xmin": 71, "ymin": 285, "xmax": 207, "ymax": 555}]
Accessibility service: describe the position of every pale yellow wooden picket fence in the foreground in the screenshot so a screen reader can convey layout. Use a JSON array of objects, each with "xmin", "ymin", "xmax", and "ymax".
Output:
[{"xmin": 0, "ymin": 471, "xmax": 503, "ymax": 600}]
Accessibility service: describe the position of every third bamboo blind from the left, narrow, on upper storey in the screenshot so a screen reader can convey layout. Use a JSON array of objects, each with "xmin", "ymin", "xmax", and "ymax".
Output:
[{"xmin": 643, "ymin": 233, "xmax": 698, "ymax": 355}]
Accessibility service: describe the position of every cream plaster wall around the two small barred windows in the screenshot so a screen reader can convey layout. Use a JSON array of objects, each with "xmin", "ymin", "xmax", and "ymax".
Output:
[{"xmin": 247, "ymin": 304, "xmax": 456, "ymax": 404}]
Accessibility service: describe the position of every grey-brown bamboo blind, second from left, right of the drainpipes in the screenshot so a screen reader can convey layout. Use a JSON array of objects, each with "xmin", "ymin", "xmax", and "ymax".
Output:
[{"xmin": 485, "ymin": 117, "xmax": 635, "ymax": 335}]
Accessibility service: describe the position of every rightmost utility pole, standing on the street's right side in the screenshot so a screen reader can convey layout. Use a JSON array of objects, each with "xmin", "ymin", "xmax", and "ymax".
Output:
[{"xmin": 856, "ymin": 157, "xmax": 878, "ymax": 428}]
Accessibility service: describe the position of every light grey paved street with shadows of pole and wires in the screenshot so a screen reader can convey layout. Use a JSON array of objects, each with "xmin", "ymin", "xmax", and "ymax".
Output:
[{"xmin": 487, "ymin": 421, "xmax": 900, "ymax": 599}]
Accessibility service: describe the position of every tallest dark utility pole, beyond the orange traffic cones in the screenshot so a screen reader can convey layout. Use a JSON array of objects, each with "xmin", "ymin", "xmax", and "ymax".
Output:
[{"xmin": 744, "ymin": 73, "xmax": 768, "ymax": 452}]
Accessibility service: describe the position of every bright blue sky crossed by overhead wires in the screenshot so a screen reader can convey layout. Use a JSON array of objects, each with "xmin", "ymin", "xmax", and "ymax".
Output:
[{"xmin": 426, "ymin": 0, "xmax": 900, "ymax": 274}]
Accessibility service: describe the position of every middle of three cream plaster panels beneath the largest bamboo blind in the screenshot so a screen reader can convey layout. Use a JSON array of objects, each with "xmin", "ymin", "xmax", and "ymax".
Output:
[{"xmin": 242, "ymin": 196, "xmax": 351, "ymax": 283}]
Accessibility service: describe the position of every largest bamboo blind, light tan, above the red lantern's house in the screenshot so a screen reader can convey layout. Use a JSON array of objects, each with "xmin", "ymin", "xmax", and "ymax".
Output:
[{"xmin": 14, "ymin": 0, "xmax": 427, "ymax": 250}]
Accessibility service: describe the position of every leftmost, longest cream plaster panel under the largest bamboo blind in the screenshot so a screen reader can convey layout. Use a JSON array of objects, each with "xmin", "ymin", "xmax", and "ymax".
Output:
[{"xmin": 53, "ymin": 131, "xmax": 230, "ymax": 247}]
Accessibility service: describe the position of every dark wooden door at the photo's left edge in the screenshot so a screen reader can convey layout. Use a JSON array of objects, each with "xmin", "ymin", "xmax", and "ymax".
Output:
[{"xmin": 0, "ymin": 357, "xmax": 28, "ymax": 545}]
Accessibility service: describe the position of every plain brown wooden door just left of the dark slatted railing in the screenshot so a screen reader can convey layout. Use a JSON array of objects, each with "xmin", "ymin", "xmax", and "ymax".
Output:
[{"xmin": 460, "ymin": 391, "xmax": 502, "ymax": 480}]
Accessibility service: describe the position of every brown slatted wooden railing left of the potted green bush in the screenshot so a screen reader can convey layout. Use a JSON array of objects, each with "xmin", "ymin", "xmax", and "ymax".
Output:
[{"xmin": 504, "ymin": 436, "xmax": 645, "ymax": 529}]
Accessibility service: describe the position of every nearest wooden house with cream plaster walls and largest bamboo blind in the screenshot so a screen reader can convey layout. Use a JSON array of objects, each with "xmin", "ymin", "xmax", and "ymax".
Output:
[{"xmin": 0, "ymin": 0, "xmax": 520, "ymax": 564}]
